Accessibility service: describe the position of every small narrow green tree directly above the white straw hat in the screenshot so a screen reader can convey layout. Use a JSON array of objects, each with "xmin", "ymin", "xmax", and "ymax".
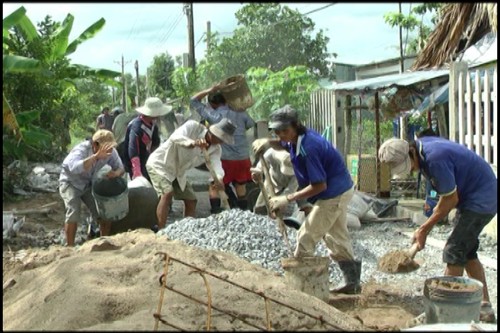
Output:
[{"xmin": 147, "ymin": 52, "xmax": 175, "ymax": 100}]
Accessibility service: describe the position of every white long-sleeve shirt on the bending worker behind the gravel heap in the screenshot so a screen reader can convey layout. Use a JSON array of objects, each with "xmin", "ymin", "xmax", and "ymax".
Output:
[{"xmin": 146, "ymin": 120, "xmax": 224, "ymax": 191}]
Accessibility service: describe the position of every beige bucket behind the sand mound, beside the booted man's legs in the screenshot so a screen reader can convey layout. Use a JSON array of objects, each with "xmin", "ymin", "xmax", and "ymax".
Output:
[{"xmin": 281, "ymin": 257, "xmax": 330, "ymax": 302}]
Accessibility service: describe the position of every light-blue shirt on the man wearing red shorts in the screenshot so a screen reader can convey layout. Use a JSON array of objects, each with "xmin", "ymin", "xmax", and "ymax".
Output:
[{"xmin": 190, "ymin": 98, "xmax": 255, "ymax": 161}]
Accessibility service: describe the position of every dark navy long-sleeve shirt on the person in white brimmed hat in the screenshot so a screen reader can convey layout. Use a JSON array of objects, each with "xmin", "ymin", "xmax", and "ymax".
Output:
[{"xmin": 124, "ymin": 116, "xmax": 160, "ymax": 179}]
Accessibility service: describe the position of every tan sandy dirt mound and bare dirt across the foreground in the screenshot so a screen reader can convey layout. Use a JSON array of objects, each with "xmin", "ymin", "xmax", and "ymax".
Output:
[{"xmin": 3, "ymin": 193, "xmax": 424, "ymax": 331}]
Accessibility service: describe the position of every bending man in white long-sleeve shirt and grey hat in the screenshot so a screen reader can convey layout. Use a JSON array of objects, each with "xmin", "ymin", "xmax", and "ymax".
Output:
[{"xmin": 146, "ymin": 118, "xmax": 236, "ymax": 229}]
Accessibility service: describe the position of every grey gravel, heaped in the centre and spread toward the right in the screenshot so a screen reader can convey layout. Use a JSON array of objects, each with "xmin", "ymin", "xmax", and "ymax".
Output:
[{"xmin": 157, "ymin": 209, "xmax": 497, "ymax": 308}]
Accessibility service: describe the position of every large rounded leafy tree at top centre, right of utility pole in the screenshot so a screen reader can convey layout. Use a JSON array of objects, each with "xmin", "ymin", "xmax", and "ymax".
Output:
[{"xmin": 201, "ymin": 3, "xmax": 332, "ymax": 77}]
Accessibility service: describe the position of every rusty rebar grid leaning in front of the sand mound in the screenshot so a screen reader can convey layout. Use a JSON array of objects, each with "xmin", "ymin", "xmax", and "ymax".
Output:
[{"xmin": 153, "ymin": 252, "xmax": 342, "ymax": 331}]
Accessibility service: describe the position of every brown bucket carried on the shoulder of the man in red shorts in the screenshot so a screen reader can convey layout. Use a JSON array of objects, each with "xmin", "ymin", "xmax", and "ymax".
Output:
[{"xmin": 219, "ymin": 74, "xmax": 254, "ymax": 112}]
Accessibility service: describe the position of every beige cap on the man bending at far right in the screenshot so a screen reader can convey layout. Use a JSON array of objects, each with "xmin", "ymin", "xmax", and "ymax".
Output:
[{"xmin": 378, "ymin": 138, "xmax": 411, "ymax": 176}]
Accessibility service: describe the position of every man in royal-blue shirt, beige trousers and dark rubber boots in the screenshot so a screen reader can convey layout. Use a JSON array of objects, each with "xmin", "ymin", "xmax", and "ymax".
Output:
[{"xmin": 252, "ymin": 105, "xmax": 361, "ymax": 294}]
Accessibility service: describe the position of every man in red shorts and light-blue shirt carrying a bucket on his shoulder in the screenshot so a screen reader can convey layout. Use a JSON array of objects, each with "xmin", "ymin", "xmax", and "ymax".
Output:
[{"xmin": 191, "ymin": 85, "xmax": 255, "ymax": 213}]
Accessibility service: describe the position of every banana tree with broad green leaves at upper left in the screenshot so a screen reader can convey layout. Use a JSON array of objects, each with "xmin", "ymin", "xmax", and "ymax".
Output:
[{"xmin": 3, "ymin": 7, "xmax": 121, "ymax": 160}]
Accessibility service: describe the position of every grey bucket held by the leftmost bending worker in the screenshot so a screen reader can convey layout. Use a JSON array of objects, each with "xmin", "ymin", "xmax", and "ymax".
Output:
[{"xmin": 92, "ymin": 177, "xmax": 128, "ymax": 221}]
